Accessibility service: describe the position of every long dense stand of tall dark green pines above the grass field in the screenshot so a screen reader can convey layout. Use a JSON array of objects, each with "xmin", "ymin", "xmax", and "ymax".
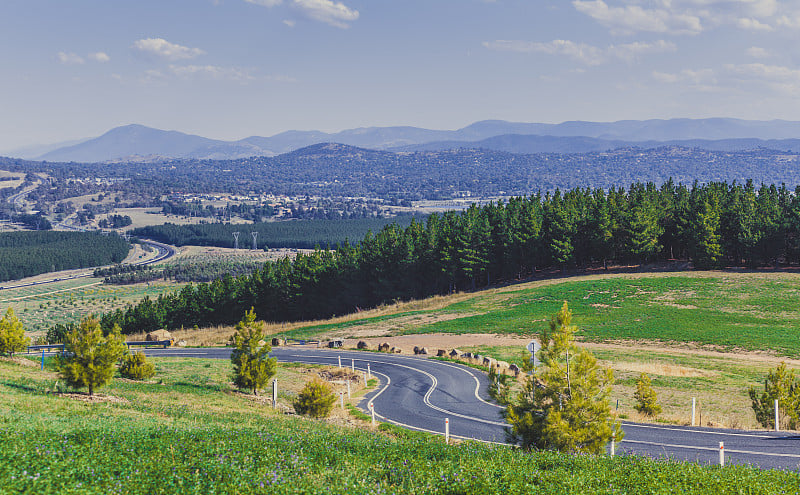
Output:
[{"xmin": 95, "ymin": 181, "xmax": 800, "ymax": 333}]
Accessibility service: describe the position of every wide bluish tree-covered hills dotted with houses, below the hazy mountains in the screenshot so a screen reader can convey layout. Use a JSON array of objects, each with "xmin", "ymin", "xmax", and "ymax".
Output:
[{"xmin": 7, "ymin": 144, "xmax": 800, "ymax": 200}]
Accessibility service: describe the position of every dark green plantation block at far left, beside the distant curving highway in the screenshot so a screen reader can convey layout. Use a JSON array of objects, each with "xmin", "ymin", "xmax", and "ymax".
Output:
[{"xmin": 0, "ymin": 230, "xmax": 130, "ymax": 282}]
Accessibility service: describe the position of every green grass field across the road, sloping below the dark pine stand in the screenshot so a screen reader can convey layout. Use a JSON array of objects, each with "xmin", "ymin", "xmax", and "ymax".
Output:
[{"xmin": 293, "ymin": 272, "xmax": 800, "ymax": 356}]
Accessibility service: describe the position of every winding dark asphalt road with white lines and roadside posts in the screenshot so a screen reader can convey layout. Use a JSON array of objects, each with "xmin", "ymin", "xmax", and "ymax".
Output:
[{"xmin": 138, "ymin": 347, "xmax": 800, "ymax": 470}]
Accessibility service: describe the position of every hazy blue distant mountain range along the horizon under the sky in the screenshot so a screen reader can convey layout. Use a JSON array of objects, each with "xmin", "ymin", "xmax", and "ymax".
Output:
[{"xmin": 9, "ymin": 118, "xmax": 800, "ymax": 162}]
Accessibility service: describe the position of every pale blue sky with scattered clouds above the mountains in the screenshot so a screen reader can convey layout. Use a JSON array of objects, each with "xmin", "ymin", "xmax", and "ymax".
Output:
[{"xmin": 0, "ymin": 0, "xmax": 800, "ymax": 151}]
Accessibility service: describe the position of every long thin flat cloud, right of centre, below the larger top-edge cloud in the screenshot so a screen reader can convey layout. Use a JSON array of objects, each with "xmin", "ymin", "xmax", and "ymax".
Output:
[{"xmin": 483, "ymin": 40, "xmax": 676, "ymax": 65}]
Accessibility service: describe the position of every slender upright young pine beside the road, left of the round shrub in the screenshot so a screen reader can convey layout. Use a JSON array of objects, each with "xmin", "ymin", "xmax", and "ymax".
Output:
[{"xmin": 231, "ymin": 308, "xmax": 277, "ymax": 395}]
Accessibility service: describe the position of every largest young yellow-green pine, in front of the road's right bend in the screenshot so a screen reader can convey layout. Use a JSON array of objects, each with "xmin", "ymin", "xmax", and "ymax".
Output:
[{"xmin": 504, "ymin": 302, "xmax": 624, "ymax": 454}]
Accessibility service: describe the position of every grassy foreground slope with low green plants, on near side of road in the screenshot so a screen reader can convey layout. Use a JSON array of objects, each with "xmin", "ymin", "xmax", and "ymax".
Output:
[{"xmin": 0, "ymin": 359, "xmax": 800, "ymax": 494}]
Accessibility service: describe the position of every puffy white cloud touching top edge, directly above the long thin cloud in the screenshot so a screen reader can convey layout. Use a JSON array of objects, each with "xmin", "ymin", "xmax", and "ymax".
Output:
[{"xmin": 572, "ymin": 0, "xmax": 703, "ymax": 34}]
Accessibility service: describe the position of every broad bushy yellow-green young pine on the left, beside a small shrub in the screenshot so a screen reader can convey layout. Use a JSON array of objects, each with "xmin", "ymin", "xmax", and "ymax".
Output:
[{"xmin": 57, "ymin": 316, "xmax": 128, "ymax": 395}]
